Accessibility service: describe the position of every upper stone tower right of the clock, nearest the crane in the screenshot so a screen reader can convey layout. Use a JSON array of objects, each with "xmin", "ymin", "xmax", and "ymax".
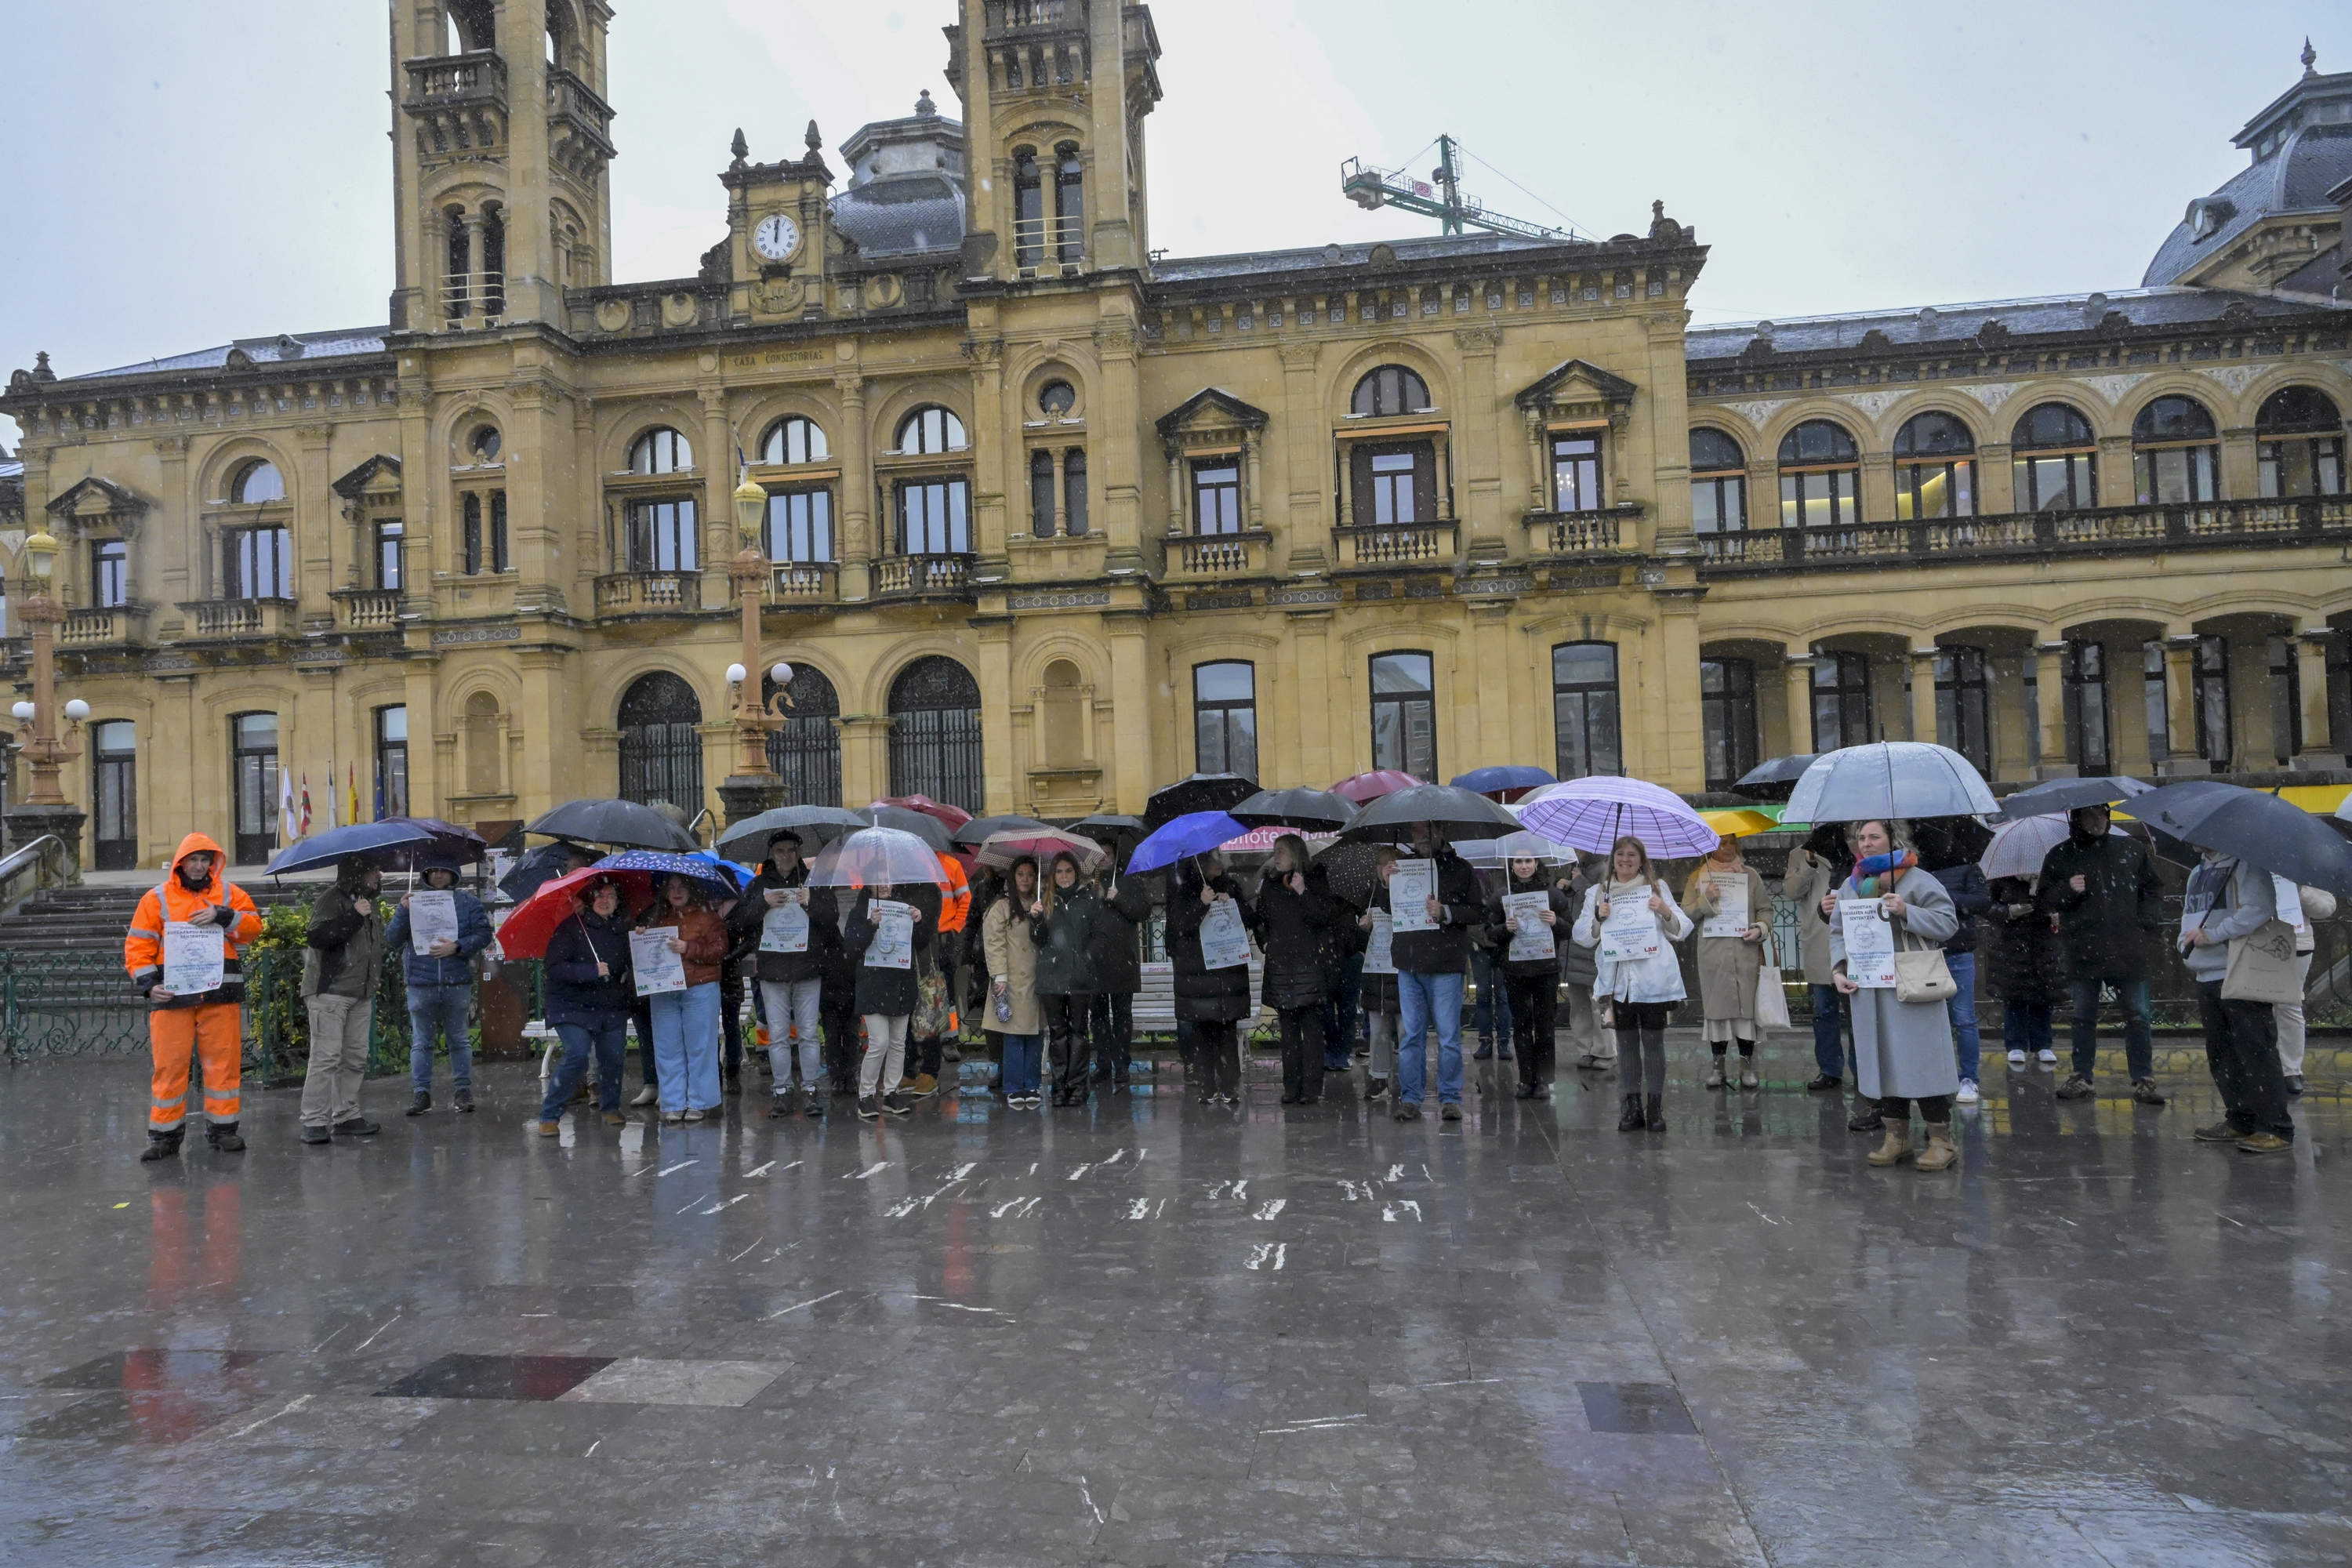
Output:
[{"xmin": 946, "ymin": 0, "xmax": 1160, "ymax": 282}]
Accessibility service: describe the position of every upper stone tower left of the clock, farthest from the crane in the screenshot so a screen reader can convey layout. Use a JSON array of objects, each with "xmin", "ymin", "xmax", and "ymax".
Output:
[{"xmin": 393, "ymin": 0, "xmax": 614, "ymax": 332}]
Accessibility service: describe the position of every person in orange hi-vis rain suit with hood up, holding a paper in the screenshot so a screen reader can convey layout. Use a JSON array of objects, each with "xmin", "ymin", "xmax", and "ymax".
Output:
[{"xmin": 122, "ymin": 832, "xmax": 261, "ymax": 1159}]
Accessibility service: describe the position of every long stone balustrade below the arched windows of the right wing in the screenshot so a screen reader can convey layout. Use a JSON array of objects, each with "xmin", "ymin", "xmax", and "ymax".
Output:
[{"xmin": 1698, "ymin": 496, "xmax": 2352, "ymax": 572}]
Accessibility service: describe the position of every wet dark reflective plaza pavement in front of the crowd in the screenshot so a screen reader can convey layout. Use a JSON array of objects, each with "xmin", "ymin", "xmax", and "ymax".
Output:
[{"xmin": 0, "ymin": 1039, "xmax": 2352, "ymax": 1568}]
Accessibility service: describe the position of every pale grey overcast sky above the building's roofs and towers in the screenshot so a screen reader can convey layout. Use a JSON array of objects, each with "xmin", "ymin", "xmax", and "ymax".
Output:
[{"xmin": 0, "ymin": 0, "xmax": 2352, "ymax": 445}]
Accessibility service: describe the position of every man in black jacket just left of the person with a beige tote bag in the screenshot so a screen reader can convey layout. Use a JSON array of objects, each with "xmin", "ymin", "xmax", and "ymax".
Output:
[{"xmin": 2034, "ymin": 806, "xmax": 2164, "ymax": 1105}]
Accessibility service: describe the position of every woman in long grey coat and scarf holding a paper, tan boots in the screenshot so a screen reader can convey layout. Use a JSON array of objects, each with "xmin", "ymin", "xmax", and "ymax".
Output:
[{"xmin": 1830, "ymin": 822, "xmax": 1959, "ymax": 1171}]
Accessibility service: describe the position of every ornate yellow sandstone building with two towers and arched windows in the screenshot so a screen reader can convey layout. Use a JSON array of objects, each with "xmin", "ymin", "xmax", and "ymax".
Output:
[{"xmin": 0, "ymin": 0, "xmax": 2352, "ymax": 865}]
